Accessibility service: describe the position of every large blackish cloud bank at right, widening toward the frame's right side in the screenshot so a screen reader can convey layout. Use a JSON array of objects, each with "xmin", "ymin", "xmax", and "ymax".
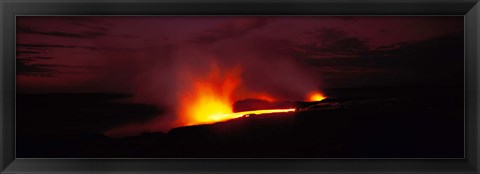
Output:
[{"xmin": 297, "ymin": 33, "xmax": 464, "ymax": 85}]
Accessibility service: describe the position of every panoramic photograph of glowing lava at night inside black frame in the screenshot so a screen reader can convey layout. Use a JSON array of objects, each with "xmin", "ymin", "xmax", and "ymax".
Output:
[{"xmin": 15, "ymin": 16, "xmax": 465, "ymax": 158}]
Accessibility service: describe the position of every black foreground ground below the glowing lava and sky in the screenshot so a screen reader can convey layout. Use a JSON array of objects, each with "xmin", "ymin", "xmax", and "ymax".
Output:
[{"xmin": 17, "ymin": 87, "xmax": 464, "ymax": 158}]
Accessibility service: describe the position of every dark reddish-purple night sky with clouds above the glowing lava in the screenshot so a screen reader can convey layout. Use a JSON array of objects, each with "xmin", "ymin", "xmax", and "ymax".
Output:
[{"xmin": 16, "ymin": 16, "xmax": 464, "ymax": 136}]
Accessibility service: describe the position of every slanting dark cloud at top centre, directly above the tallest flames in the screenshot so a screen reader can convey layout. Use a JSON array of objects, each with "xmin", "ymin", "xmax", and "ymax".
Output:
[{"xmin": 191, "ymin": 17, "xmax": 269, "ymax": 44}]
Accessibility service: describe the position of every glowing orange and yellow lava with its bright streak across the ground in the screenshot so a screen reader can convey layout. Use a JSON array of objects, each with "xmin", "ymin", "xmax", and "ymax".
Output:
[{"xmin": 178, "ymin": 64, "xmax": 326, "ymax": 125}]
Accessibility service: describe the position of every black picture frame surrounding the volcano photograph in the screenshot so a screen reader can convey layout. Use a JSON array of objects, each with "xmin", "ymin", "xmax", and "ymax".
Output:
[{"xmin": 0, "ymin": 0, "xmax": 480, "ymax": 173}]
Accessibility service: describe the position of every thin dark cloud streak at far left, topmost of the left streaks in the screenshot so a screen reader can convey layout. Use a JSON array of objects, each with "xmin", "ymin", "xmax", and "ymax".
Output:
[{"xmin": 17, "ymin": 27, "xmax": 107, "ymax": 39}]
